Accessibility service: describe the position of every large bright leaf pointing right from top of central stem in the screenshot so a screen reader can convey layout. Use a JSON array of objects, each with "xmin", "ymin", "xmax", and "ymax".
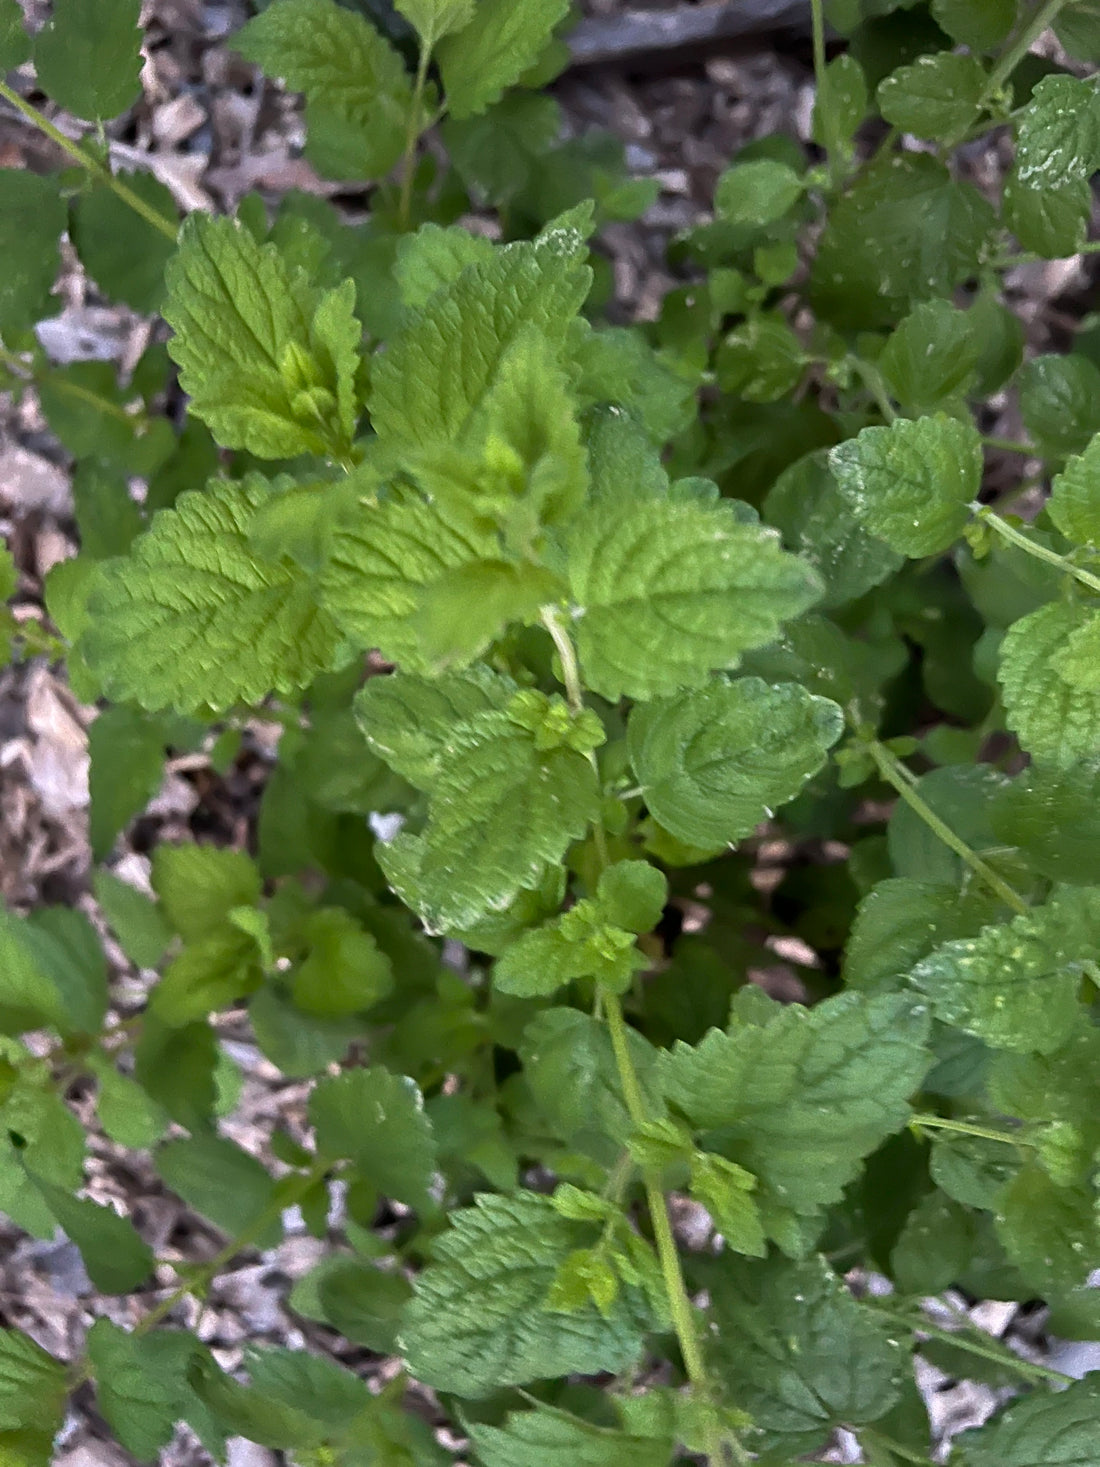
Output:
[{"xmin": 568, "ymin": 499, "xmax": 820, "ymax": 700}]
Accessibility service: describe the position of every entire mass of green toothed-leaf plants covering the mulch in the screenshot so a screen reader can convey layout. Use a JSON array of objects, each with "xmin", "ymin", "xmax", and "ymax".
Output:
[{"xmin": 0, "ymin": 0, "xmax": 1100, "ymax": 1467}]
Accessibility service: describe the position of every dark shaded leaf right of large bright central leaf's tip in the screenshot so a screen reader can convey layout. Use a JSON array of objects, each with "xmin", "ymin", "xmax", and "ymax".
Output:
[{"xmin": 764, "ymin": 452, "xmax": 902, "ymax": 607}]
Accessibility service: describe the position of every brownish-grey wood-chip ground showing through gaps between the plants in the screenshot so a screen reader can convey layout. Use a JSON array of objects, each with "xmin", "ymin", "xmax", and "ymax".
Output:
[{"xmin": 0, "ymin": 0, "xmax": 1100, "ymax": 1467}]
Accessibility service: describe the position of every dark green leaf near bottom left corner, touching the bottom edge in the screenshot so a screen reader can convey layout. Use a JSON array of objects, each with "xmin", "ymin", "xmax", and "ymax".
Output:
[{"xmin": 87, "ymin": 1319, "xmax": 224, "ymax": 1463}]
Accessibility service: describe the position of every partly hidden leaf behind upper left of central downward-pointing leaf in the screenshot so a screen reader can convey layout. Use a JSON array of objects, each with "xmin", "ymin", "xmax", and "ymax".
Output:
[{"xmin": 355, "ymin": 665, "xmax": 516, "ymax": 789}]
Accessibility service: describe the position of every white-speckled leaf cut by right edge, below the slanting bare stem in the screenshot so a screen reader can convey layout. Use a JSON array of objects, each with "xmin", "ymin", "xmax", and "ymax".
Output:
[{"xmin": 909, "ymin": 888, "xmax": 1100, "ymax": 1053}]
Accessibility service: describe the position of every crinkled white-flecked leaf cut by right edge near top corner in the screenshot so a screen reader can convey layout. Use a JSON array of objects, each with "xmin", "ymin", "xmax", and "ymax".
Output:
[{"xmin": 1016, "ymin": 73, "xmax": 1100, "ymax": 188}]
